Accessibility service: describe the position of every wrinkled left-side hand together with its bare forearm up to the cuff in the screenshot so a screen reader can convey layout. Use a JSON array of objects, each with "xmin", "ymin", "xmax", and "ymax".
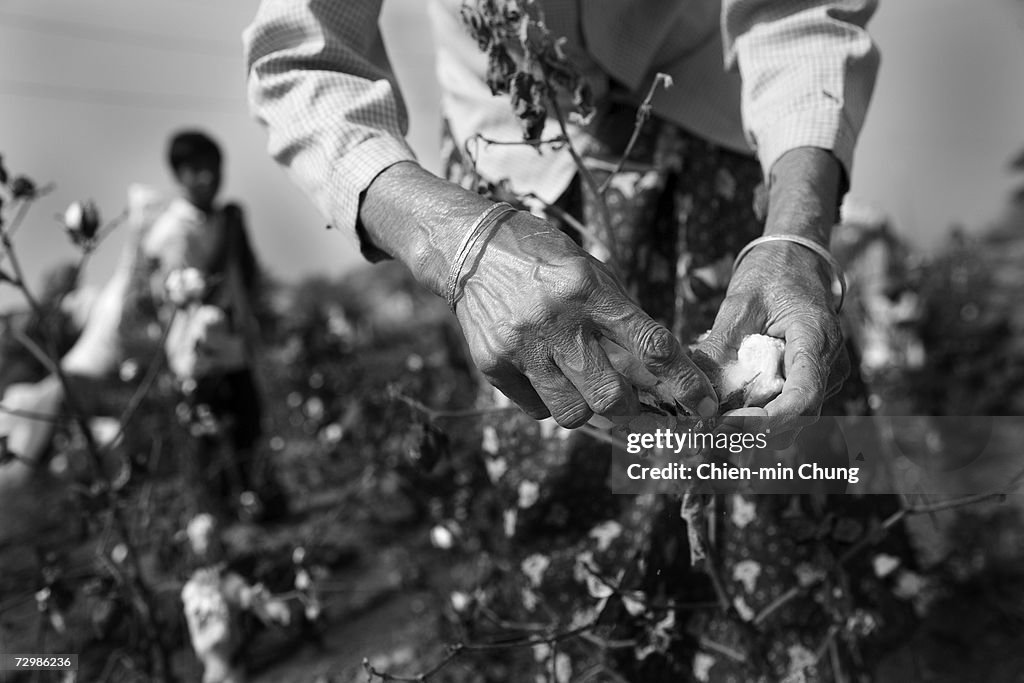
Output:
[{"xmin": 360, "ymin": 163, "xmax": 718, "ymax": 428}]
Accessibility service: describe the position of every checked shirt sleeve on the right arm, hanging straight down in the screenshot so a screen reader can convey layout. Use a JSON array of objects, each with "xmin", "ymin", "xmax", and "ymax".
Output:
[{"xmin": 722, "ymin": 0, "xmax": 879, "ymax": 177}]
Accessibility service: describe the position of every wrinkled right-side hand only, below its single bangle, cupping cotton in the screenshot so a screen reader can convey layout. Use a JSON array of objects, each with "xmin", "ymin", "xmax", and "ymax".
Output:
[{"xmin": 698, "ymin": 242, "xmax": 849, "ymax": 436}]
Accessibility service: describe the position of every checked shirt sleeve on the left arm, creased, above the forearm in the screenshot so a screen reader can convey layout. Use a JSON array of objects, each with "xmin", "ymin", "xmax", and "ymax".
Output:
[{"xmin": 243, "ymin": 0, "xmax": 415, "ymax": 260}]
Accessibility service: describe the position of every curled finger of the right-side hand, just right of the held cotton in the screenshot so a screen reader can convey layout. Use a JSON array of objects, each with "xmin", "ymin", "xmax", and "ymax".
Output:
[{"xmin": 765, "ymin": 318, "xmax": 839, "ymax": 433}]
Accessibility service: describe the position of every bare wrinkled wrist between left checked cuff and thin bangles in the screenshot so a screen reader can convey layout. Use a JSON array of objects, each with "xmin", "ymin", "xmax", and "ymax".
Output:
[{"xmin": 359, "ymin": 162, "xmax": 494, "ymax": 296}]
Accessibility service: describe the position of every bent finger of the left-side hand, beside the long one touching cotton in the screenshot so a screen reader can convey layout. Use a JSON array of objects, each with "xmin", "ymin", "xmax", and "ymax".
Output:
[{"xmin": 554, "ymin": 337, "xmax": 640, "ymax": 416}]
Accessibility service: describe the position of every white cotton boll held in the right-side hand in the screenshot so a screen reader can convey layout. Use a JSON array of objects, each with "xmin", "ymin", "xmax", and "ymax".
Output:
[{"xmin": 718, "ymin": 335, "xmax": 785, "ymax": 407}]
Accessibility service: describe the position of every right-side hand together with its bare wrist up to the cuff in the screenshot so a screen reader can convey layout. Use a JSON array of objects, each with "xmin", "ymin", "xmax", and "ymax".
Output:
[{"xmin": 698, "ymin": 147, "xmax": 849, "ymax": 435}]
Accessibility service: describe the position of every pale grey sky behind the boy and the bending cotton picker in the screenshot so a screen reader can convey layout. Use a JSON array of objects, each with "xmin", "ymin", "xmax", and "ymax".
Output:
[{"xmin": 0, "ymin": 0, "xmax": 1024, "ymax": 303}]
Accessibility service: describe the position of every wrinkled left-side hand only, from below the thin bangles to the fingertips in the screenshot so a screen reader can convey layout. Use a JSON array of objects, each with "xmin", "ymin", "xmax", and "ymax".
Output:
[{"xmin": 457, "ymin": 212, "xmax": 718, "ymax": 428}]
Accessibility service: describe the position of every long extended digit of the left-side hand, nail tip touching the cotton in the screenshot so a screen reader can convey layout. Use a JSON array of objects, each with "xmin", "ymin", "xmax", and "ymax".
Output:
[{"xmin": 595, "ymin": 300, "xmax": 718, "ymax": 417}]
